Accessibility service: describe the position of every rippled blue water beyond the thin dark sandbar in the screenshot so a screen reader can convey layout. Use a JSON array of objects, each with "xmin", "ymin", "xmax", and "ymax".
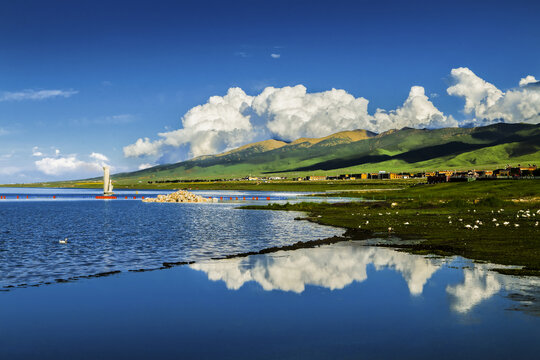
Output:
[{"xmin": 0, "ymin": 193, "xmax": 343, "ymax": 288}]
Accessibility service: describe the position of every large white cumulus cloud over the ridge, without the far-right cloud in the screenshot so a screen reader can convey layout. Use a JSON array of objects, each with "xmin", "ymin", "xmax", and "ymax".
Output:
[{"xmin": 124, "ymin": 85, "xmax": 457, "ymax": 157}]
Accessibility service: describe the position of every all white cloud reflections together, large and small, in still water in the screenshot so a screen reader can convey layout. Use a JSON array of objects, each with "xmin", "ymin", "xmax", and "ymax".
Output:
[{"xmin": 190, "ymin": 242, "xmax": 540, "ymax": 313}]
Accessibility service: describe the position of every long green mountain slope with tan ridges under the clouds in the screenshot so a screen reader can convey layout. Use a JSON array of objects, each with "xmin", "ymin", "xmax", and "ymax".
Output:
[{"xmin": 114, "ymin": 123, "xmax": 540, "ymax": 181}]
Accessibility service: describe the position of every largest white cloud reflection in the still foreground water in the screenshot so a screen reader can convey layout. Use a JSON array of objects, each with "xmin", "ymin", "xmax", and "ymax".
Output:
[{"xmin": 191, "ymin": 243, "xmax": 440, "ymax": 295}]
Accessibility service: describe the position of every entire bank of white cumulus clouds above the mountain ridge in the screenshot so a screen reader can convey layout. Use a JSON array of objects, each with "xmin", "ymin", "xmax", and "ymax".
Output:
[{"xmin": 124, "ymin": 67, "xmax": 540, "ymax": 160}]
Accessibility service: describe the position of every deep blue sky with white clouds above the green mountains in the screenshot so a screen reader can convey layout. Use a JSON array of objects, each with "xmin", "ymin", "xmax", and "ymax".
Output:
[{"xmin": 0, "ymin": 1, "xmax": 540, "ymax": 183}]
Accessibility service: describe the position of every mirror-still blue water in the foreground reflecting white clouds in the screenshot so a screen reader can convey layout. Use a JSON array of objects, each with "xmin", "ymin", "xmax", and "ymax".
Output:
[{"xmin": 0, "ymin": 242, "xmax": 540, "ymax": 359}]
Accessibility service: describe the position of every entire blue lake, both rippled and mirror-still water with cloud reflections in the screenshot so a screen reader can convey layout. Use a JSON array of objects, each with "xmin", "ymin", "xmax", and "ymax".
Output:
[{"xmin": 0, "ymin": 188, "xmax": 540, "ymax": 359}]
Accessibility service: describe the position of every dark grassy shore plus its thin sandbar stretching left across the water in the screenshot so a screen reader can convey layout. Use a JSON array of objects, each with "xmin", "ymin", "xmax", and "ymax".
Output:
[{"xmin": 0, "ymin": 181, "xmax": 540, "ymax": 291}]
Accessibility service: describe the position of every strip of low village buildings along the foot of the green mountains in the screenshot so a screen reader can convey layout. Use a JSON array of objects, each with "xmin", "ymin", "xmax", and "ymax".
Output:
[{"xmin": 148, "ymin": 164, "xmax": 540, "ymax": 184}]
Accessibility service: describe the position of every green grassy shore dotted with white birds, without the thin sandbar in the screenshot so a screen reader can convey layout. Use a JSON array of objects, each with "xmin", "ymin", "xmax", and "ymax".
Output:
[{"xmin": 244, "ymin": 180, "xmax": 540, "ymax": 276}]
